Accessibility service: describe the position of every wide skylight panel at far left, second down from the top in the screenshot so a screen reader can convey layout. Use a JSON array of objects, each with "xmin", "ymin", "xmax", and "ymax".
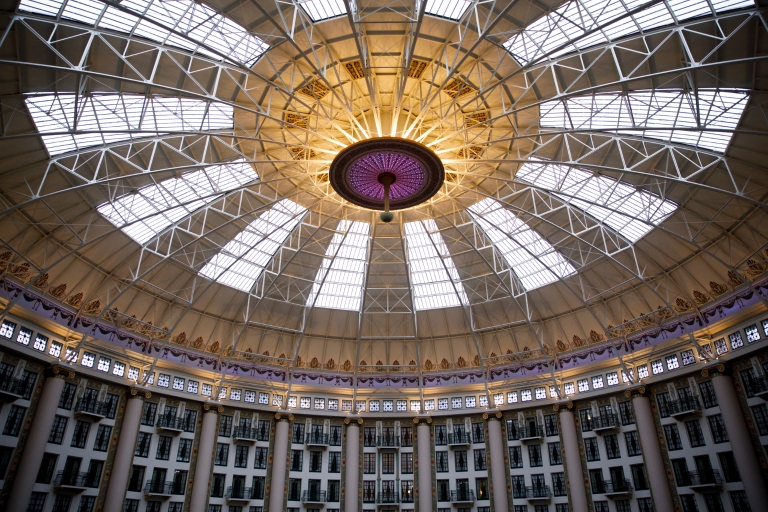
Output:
[{"xmin": 25, "ymin": 94, "xmax": 234, "ymax": 156}]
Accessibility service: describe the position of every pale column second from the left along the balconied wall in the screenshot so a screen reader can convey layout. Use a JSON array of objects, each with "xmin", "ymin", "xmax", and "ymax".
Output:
[{"xmin": 104, "ymin": 389, "xmax": 149, "ymax": 512}]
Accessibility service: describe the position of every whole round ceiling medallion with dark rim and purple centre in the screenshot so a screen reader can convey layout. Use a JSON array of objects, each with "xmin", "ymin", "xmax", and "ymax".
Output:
[{"xmin": 329, "ymin": 137, "xmax": 445, "ymax": 210}]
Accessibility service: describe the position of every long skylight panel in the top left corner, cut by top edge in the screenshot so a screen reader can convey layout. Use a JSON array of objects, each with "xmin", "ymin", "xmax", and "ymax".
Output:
[{"xmin": 19, "ymin": 0, "xmax": 269, "ymax": 66}]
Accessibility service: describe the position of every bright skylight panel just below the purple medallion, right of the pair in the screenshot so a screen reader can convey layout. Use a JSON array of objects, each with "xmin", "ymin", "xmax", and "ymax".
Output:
[{"xmin": 405, "ymin": 219, "xmax": 469, "ymax": 311}]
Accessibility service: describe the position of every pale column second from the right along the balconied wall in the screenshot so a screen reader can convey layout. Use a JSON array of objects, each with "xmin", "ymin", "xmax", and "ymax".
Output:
[{"xmin": 632, "ymin": 391, "xmax": 675, "ymax": 510}]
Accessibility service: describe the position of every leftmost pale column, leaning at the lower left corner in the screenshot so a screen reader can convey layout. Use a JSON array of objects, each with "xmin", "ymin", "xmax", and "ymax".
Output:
[{"xmin": 5, "ymin": 366, "xmax": 68, "ymax": 512}]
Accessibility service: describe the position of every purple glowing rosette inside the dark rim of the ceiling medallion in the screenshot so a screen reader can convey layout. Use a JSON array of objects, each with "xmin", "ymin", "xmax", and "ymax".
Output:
[{"xmin": 348, "ymin": 151, "xmax": 426, "ymax": 201}]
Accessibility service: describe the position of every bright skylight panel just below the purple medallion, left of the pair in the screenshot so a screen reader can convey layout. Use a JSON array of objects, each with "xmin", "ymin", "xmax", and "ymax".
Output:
[{"xmin": 307, "ymin": 220, "xmax": 371, "ymax": 311}]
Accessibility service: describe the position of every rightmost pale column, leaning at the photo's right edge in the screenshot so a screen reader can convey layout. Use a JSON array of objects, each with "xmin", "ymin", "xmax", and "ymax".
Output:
[{"xmin": 712, "ymin": 368, "xmax": 768, "ymax": 510}]
